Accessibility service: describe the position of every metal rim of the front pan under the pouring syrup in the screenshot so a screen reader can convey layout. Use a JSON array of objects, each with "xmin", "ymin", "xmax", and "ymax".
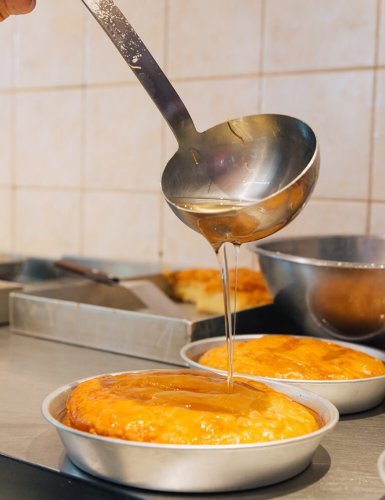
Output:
[{"xmin": 41, "ymin": 368, "xmax": 339, "ymax": 452}]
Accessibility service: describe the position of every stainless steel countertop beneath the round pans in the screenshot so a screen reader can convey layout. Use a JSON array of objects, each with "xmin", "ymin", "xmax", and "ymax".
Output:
[{"xmin": 0, "ymin": 328, "xmax": 385, "ymax": 500}]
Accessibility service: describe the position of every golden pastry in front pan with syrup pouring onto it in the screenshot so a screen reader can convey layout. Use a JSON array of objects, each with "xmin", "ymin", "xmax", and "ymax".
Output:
[{"xmin": 64, "ymin": 370, "xmax": 322, "ymax": 445}]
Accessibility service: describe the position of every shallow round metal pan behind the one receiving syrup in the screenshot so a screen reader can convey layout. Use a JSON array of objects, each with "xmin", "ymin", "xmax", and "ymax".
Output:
[{"xmin": 180, "ymin": 334, "xmax": 385, "ymax": 414}]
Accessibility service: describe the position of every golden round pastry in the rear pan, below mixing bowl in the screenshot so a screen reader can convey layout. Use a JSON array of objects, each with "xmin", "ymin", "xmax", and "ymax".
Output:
[{"xmin": 199, "ymin": 335, "xmax": 385, "ymax": 380}]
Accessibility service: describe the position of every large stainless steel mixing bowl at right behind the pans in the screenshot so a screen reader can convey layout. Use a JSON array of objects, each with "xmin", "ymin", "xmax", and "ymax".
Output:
[{"xmin": 249, "ymin": 235, "xmax": 385, "ymax": 347}]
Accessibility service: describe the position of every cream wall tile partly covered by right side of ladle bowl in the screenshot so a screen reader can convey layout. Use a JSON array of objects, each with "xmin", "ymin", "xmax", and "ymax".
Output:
[{"xmin": 262, "ymin": 71, "xmax": 373, "ymax": 199}]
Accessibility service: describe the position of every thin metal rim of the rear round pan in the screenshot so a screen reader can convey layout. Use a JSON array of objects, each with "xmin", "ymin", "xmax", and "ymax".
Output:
[{"xmin": 180, "ymin": 333, "xmax": 385, "ymax": 386}]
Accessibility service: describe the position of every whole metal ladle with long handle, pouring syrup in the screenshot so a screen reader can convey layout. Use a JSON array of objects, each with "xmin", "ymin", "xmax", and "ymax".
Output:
[{"xmin": 82, "ymin": 0, "xmax": 319, "ymax": 243}]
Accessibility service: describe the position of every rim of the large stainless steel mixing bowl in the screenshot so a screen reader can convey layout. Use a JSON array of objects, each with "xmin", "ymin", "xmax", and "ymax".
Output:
[{"xmin": 247, "ymin": 234, "xmax": 385, "ymax": 270}]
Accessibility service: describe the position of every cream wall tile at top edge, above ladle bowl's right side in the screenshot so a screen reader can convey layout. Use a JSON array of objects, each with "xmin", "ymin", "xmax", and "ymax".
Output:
[{"xmin": 264, "ymin": 0, "xmax": 377, "ymax": 72}]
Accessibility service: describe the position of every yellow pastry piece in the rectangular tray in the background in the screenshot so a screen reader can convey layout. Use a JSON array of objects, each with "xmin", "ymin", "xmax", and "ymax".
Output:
[{"xmin": 166, "ymin": 267, "xmax": 273, "ymax": 314}]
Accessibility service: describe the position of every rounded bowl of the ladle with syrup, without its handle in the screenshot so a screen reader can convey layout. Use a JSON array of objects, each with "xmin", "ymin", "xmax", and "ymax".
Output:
[{"xmin": 162, "ymin": 114, "xmax": 319, "ymax": 248}]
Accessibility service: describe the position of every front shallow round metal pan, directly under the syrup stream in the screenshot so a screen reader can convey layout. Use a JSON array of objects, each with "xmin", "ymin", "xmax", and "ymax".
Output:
[{"xmin": 42, "ymin": 370, "xmax": 339, "ymax": 493}]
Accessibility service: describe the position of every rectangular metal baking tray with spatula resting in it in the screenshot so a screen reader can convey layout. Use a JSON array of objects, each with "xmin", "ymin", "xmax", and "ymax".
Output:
[{"xmin": 10, "ymin": 275, "xmax": 270, "ymax": 365}]
